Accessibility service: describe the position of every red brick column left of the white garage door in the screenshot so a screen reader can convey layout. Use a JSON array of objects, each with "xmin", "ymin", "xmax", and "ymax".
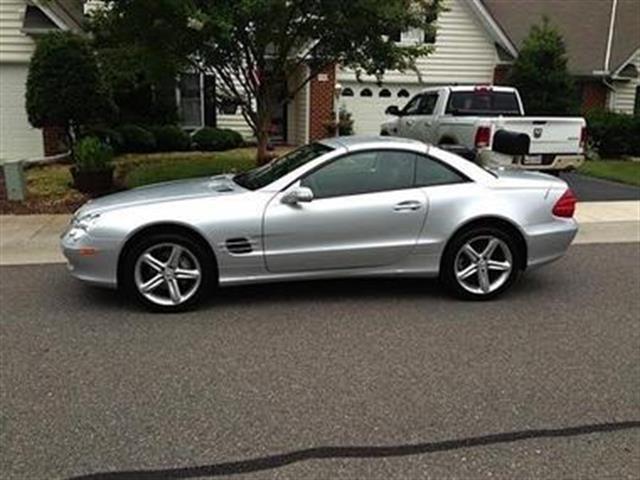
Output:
[{"xmin": 309, "ymin": 65, "xmax": 336, "ymax": 141}]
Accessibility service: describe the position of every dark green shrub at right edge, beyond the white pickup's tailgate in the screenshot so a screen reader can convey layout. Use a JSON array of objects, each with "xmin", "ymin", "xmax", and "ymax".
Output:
[{"xmin": 586, "ymin": 110, "xmax": 640, "ymax": 157}]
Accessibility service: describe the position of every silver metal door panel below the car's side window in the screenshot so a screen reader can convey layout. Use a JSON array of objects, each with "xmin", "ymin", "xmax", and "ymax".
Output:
[{"xmin": 264, "ymin": 188, "xmax": 427, "ymax": 272}]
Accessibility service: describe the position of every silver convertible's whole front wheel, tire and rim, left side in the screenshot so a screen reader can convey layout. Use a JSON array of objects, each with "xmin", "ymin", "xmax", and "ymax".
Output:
[{"xmin": 121, "ymin": 233, "xmax": 214, "ymax": 312}]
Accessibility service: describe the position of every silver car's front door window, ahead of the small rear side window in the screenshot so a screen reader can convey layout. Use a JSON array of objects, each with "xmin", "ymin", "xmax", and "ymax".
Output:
[{"xmin": 300, "ymin": 150, "xmax": 416, "ymax": 198}]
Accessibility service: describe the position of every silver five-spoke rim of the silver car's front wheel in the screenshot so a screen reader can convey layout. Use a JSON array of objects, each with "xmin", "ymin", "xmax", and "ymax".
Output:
[{"xmin": 134, "ymin": 243, "xmax": 202, "ymax": 305}]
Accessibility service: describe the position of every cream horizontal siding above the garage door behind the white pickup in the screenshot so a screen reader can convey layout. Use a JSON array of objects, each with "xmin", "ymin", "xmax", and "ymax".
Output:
[{"xmin": 338, "ymin": 0, "xmax": 498, "ymax": 85}]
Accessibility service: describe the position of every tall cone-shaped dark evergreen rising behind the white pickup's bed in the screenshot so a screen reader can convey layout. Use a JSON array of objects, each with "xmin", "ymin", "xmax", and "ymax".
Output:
[{"xmin": 509, "ymin": 17, "xmax": 576, "ymax": 115}]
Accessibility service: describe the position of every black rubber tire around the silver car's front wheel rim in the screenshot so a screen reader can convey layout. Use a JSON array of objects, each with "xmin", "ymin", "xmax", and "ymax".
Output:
[{"xmin": 119, "ymin": 233, "xmax": 217, "ymax": 313}]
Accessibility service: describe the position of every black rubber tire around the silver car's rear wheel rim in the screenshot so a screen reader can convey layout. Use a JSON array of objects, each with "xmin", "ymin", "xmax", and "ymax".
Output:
[{"xmin": 440, "ymin": 226, "xmax": 523, "ymax": 301}]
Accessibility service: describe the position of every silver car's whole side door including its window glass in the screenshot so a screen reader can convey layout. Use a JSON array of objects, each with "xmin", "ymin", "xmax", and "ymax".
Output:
[{"xmin": 263, "ymin": 150, "xmax": 427, "ymax": 272}]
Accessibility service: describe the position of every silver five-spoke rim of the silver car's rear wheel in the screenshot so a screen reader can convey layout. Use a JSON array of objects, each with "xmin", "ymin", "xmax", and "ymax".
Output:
[{"xmin": 455, "ymin": 235, "xmax": 513, "ymax": 295}]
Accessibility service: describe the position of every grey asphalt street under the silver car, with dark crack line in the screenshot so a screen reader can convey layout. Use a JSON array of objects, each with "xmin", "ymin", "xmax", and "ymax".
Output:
[{"xmin": 0, "ymin": 244, "xmax": 640, "ymax": 480}]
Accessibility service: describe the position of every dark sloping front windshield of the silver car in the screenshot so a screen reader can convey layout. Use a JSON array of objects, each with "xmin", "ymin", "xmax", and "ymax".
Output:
[{"xmin": 233, "ymin": 143, "xmax": 333, "ymax": 190}]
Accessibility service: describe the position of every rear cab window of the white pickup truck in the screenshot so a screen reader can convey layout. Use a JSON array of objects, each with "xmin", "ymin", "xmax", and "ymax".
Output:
[{"xmin": 446, "ymin": 90, "xmax": 522, "ymax": 116}]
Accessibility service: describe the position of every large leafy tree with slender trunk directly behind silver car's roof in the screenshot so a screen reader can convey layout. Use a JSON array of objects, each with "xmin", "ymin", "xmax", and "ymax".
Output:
[{"xmin": 91, "ymin": 0, "xmax": 441, "ymax": 161}]
